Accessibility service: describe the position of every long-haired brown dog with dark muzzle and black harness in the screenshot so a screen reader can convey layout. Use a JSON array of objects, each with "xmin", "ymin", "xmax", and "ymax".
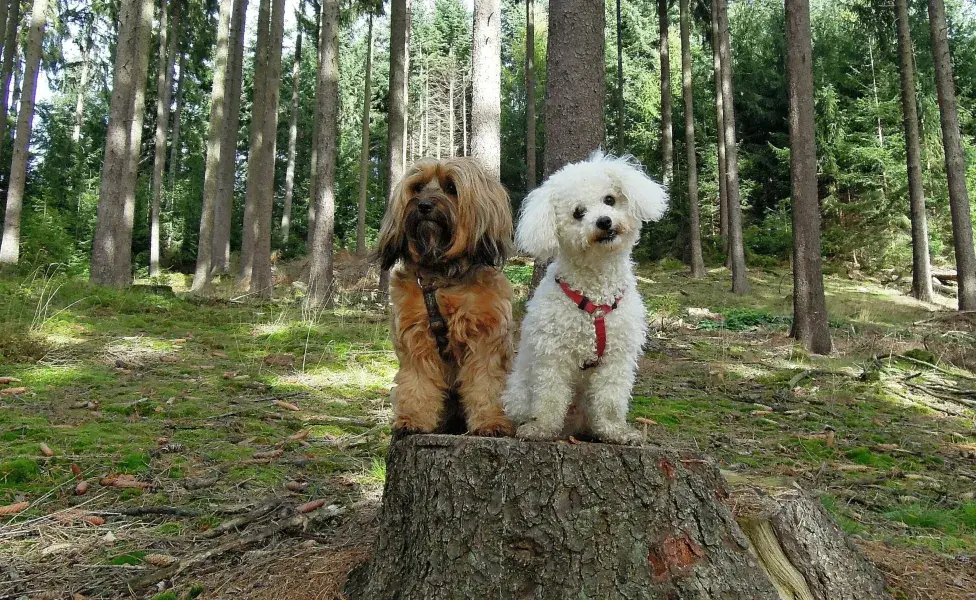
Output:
[{"xmin": 378, "ymin": 158, "xmax": 513, "ymax": 436}]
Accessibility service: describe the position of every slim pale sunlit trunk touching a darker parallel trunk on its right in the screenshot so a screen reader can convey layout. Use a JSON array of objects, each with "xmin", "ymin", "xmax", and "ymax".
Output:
[{"xmin": 190, "ymin": 0, "xmax": 234, "ymax": 294}]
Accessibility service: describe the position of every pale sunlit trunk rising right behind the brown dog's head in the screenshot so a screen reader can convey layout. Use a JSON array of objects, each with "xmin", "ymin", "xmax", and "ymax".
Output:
[{"xmin": 471, "ymin": 0, "xmax": 502, "ymax": 179}]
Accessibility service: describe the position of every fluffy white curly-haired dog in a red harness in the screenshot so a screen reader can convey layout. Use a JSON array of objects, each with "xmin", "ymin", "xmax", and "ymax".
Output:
[{"xmin": 502, "ymin": 150, "xmax": 668, "ymax": 444}]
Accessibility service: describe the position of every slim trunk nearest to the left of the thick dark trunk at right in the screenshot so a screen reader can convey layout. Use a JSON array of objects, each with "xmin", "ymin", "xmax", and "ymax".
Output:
[{"xmin": 715, "ymin": 0, "xmax": 749, "ymax": 294}]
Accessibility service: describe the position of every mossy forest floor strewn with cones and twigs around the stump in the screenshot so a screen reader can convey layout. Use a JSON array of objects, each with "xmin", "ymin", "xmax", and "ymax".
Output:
[{"xmin": 0, "ymin": 257, "xmax": 976, "ymax": 600}]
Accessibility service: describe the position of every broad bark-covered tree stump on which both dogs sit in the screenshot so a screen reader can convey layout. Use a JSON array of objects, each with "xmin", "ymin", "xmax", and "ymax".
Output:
[{"xmin": 345, "ymin": 435, "xmax": 883, "ymax": 600}]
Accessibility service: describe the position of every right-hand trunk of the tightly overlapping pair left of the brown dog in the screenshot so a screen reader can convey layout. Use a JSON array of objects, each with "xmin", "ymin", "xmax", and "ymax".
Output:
[{"xmin": 250, "ymin": 0, "xmax": 286, "ymax": 296}]
